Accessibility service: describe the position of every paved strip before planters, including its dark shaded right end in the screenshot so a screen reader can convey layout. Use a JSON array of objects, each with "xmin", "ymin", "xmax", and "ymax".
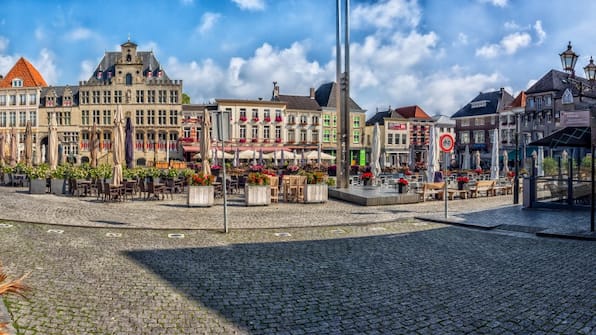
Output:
[{"xmin": 0, "ymin": 187, "xmax": 596, "ymax": 240}]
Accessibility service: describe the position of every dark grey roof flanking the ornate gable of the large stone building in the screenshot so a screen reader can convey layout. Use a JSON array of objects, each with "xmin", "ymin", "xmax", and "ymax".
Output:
[{"xmin": 88, "ymin": 51, "xmax": 170, "ymax": 84}]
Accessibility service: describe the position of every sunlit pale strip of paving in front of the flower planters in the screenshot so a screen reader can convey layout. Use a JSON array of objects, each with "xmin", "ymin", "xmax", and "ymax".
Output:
[{"xmin": 0, "ymin": 187, "xmax": 512, "ymax": 230}]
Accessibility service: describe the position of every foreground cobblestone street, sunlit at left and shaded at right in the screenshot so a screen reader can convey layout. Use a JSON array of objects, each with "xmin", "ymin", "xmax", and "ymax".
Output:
[{"xmin": 0, "ymin": 220, "xmax": 596, "ymax": 335}]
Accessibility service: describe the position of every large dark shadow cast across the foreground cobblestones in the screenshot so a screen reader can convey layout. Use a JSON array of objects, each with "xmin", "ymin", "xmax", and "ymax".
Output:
[{"xmin": 125, "ymin": 227, "xmax": 596, "ymax": 334}]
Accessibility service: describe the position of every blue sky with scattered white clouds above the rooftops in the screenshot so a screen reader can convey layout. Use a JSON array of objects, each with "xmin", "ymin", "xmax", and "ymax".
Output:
[{"xmin": 0, "ymin": 0, "xmax": 596, "ymax": 115}]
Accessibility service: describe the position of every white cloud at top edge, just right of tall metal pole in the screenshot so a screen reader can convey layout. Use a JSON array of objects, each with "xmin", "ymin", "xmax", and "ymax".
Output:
[{"xmin": 350, "ymin": 0, "xmax": 422, "ymax": 29}]
